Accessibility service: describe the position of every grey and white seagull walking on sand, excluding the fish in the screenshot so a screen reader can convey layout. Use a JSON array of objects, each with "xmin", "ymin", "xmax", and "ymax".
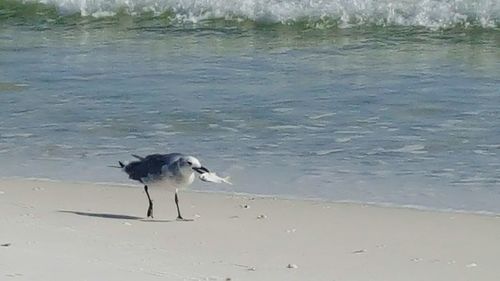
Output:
[{"xmin": 118, "ymin": 153, "xmax": 209, "ymax": 220}]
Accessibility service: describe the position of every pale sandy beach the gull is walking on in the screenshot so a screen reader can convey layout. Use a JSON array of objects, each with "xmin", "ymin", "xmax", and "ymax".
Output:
[{"xmin": 0, "ymin": 180, "xmax": 500, "ymax": 281}]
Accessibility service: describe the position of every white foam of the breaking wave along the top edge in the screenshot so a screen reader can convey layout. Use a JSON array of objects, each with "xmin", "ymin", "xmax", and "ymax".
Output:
[{"xmin": 39, "ymin": 0, "xmax": 500, "ymax": 28}]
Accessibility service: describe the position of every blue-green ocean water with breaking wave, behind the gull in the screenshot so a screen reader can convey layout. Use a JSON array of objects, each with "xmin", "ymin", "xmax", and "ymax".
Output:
[{"xmin": 0, "ymin": 0, "xmax": 500, "ymax": 213}]
